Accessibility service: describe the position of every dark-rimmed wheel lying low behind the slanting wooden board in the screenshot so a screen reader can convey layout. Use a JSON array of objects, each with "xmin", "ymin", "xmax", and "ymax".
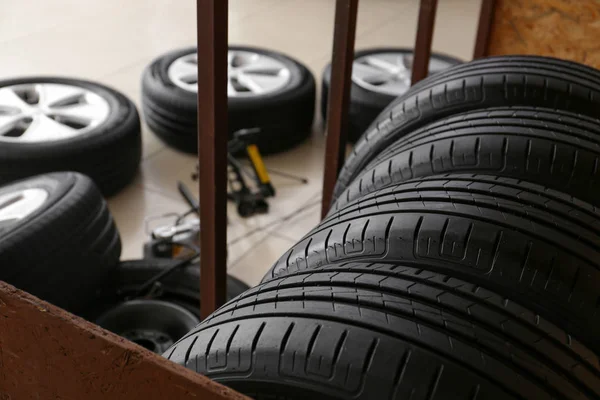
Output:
[{"xmin": 82, "ymin": 259, "xmax": 248, "ymax": 354}]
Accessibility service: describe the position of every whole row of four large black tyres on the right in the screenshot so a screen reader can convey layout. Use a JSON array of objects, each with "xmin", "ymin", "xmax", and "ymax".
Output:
[{"xmin": 165, "ymin": 56, "xmax": 600, "ymax": 400}]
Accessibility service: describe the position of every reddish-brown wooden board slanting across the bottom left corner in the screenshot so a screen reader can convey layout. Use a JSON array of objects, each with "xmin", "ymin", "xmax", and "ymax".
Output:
[{"xmin": 0, "ymin": 282, "xmax": 247, "ymax": 400}]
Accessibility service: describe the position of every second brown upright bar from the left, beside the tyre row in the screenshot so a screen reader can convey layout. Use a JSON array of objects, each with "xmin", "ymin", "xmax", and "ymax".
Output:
[{"xmin": 321, "ymin": 0, "xmax": 358, "ymax": 217}]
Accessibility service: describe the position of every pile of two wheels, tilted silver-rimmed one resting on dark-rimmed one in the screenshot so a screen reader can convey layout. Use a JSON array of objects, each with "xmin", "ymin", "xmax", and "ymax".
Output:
[{"xmin": 0, "ymin": 172, "xmax": 248, "ymax": 353}]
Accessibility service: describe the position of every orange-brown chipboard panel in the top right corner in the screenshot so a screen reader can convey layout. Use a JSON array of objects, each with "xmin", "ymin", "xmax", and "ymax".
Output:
[{"xmin": 488, "ymin": 0, "xmax": 600, "ymax": 68}]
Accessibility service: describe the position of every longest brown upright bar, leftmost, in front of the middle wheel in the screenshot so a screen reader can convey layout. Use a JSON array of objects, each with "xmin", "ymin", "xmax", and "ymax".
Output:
[{"xmin": 196, "ymin": 0, "xmax": 228, "ymax": 318}]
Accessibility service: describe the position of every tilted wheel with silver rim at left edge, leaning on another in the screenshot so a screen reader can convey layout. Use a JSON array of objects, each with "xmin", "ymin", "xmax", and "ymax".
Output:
[{"xmin": 0, "ymin": 172, "xmax": 121, "ymax": 313}]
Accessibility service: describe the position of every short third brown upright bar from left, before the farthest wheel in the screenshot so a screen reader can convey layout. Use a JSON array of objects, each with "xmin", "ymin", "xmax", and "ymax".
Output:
[{"xmin": 411, "ymin": 0, "xmax": 437, "ymax": 85}]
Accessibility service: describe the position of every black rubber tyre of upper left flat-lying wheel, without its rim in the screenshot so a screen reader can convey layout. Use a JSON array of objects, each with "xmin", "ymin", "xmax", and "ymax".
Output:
[{"xmin": 0, "ymin": 77, "xmax": 142, "ymax": 196}]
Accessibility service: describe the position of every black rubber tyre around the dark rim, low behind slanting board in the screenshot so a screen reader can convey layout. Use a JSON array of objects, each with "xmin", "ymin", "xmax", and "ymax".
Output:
[{"xmin": 83, "ymin": 259, "xmax": 249, "ymax": 321}]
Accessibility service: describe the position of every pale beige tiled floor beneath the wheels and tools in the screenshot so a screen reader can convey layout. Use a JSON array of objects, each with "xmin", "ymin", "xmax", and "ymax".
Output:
[{"xmin": 0, "ymin": 0, "xmax": 480, "ymax": 284}]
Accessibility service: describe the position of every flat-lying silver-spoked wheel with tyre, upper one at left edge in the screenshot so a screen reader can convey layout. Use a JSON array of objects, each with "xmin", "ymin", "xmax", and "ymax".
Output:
[{"xmin": 0, "ymin": 77, "xmax": 142, "ymax": 196}]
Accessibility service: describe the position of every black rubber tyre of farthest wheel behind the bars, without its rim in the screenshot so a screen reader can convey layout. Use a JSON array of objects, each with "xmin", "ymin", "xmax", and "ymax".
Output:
[{"xmin": 321, "ymin": 47, "xmax": 462, "ymax": 143}]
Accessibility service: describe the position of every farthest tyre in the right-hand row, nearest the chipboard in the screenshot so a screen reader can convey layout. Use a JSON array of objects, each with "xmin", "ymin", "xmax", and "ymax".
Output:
[{"xmin": 333, "ymin": 56, "xmax": 600, "ymax": 203}]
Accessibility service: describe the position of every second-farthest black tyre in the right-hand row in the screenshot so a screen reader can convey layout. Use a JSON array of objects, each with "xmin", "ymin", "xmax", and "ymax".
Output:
[{"xmin": 330, "ymin": 107, "xmax": 600, "ymax": 213}]
